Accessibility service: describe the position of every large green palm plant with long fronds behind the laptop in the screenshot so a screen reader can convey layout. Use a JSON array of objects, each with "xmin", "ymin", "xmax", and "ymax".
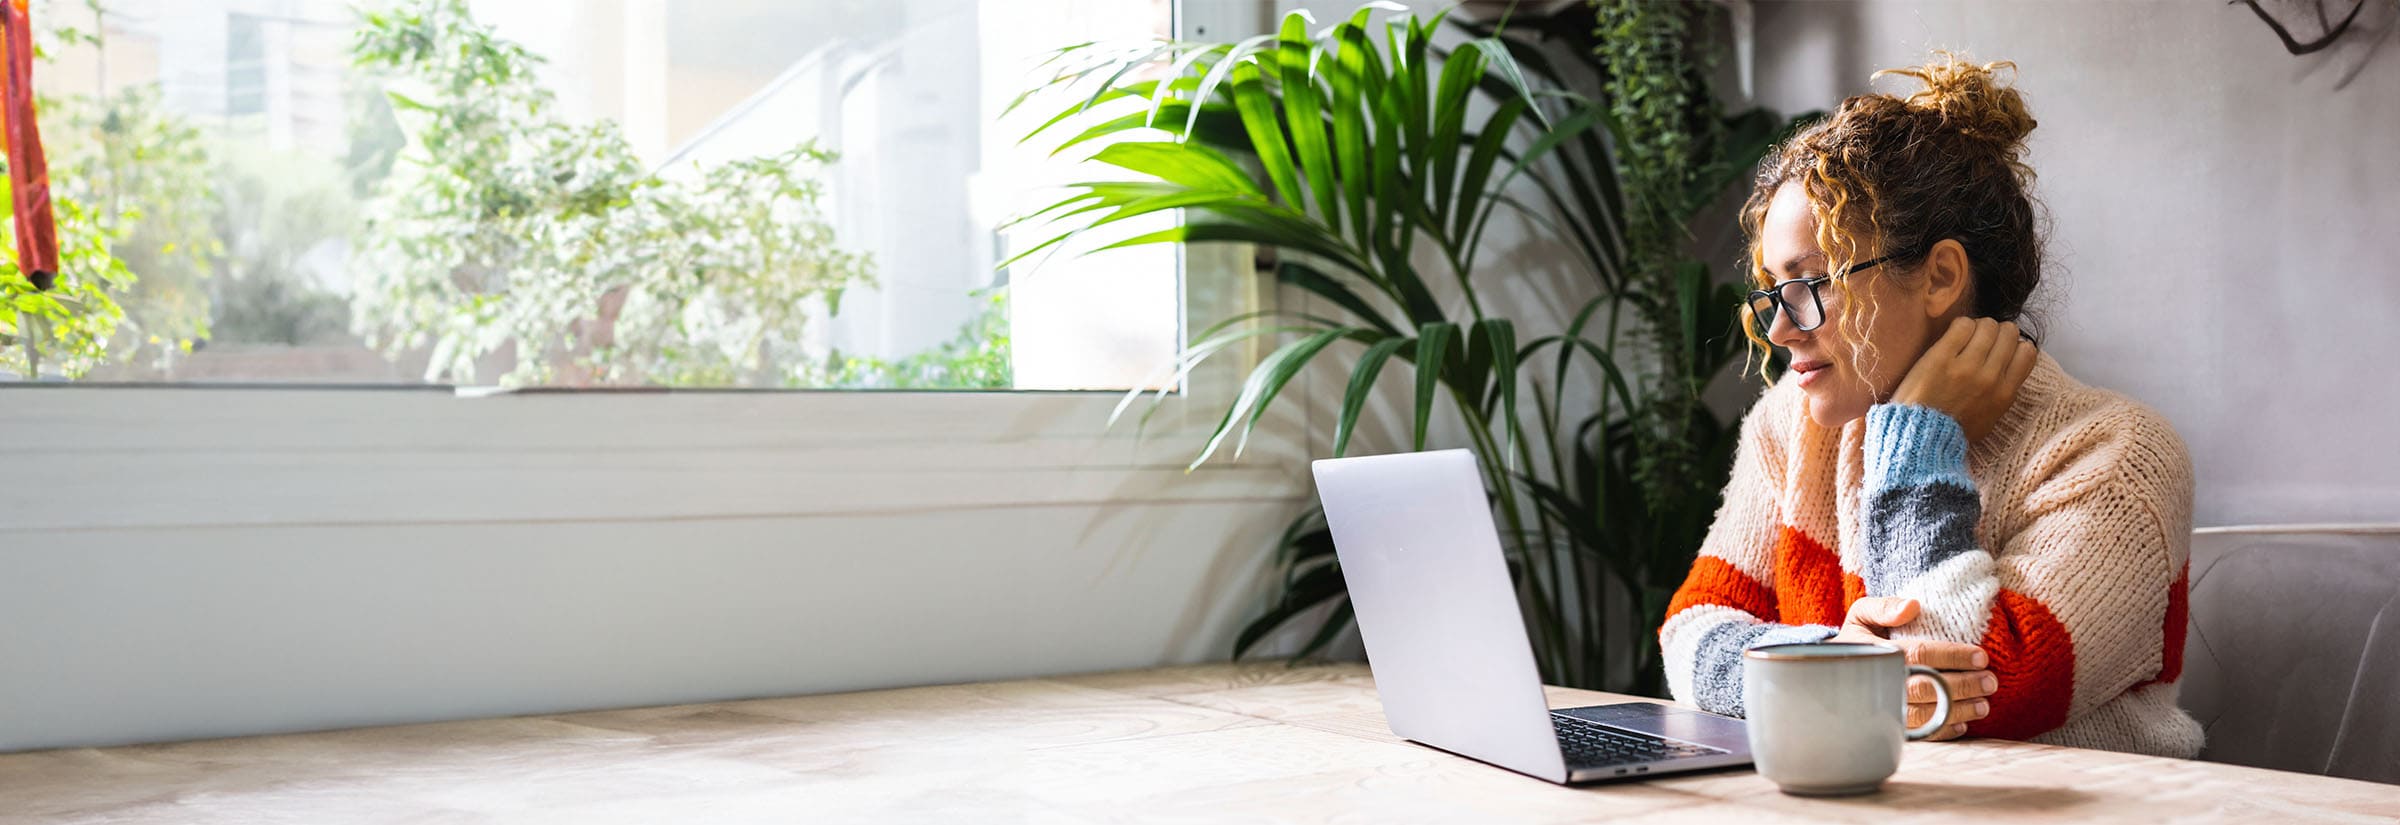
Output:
[{"xmin": 1003, "ymin": 5, "xmax": 1804, "ymax": 688}]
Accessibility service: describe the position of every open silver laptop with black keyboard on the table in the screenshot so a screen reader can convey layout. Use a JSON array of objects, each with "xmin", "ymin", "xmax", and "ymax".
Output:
[{"xmin": 1315, "ymin": 451, "xmax": 1750, "ymax": 782}]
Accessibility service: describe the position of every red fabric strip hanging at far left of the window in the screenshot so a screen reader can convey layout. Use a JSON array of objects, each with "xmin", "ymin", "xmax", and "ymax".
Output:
[{"xmin": 0, "ymin": 0, "xmax": 58, "ymax": 290}]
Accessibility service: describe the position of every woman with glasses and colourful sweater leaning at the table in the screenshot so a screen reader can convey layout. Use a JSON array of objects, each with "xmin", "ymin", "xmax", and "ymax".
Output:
[{"xmin": 1658, "ymin": 55, "xmax": 2201, "ymax": 758}]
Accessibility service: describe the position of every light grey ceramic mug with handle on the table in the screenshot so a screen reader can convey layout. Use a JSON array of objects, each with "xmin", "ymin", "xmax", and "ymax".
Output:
[{"xmin": 1742, "ymin": 643, "xmax": 1951, "ymax": 796}]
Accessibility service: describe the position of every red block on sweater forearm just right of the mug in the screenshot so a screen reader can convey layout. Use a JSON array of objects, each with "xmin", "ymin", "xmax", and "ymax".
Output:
[{"xmin": 1966, "ymin": 590, "xmax": 2076, "ymax": 739}]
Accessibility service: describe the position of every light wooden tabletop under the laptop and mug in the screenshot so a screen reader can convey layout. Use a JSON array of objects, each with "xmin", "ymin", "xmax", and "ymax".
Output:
[{"xmin": 0, "ymin": 664, "xmax": 2400, "ymax": 825}]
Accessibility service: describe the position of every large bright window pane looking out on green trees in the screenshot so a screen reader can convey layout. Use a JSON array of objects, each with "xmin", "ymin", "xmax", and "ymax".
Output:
[{"xmin": 18, "ymin": 0, "xmax": 1181, "ymax": 389}]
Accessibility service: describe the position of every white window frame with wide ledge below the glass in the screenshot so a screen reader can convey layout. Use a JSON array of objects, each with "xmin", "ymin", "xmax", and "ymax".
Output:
[{"xmin": 0, "ymin": 0, "xmax": 1310, "ymax": 532}]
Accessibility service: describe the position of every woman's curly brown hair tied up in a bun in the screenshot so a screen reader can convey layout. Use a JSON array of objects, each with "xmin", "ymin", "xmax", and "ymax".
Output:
[{"xmin": 1742, "ymin": 53, "xmax": 2042, "ymax": 377}]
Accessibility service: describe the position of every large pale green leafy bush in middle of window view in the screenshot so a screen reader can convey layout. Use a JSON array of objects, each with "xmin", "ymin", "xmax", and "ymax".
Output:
[{"xmin": 353, "ymin": 0, "xmax": 874, "ymax": 386}]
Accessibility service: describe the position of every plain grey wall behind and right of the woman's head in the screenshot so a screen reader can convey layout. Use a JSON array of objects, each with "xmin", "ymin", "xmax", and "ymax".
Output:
[{"xmin": 1757, "ymin": 2, "xmax": 2400, "ymax": 525}]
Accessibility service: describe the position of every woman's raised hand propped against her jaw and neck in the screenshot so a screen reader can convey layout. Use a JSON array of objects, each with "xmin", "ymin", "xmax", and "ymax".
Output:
[{"xmin": 1891, "ymin": 317, "xmax": 2040, "ymax": 444}]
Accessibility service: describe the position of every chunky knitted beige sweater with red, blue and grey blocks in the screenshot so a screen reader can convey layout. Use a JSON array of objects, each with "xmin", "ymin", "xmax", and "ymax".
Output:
[{"xmin": 1658, "ymin": 353, "xmax": 2201, "ymax": 758}]
